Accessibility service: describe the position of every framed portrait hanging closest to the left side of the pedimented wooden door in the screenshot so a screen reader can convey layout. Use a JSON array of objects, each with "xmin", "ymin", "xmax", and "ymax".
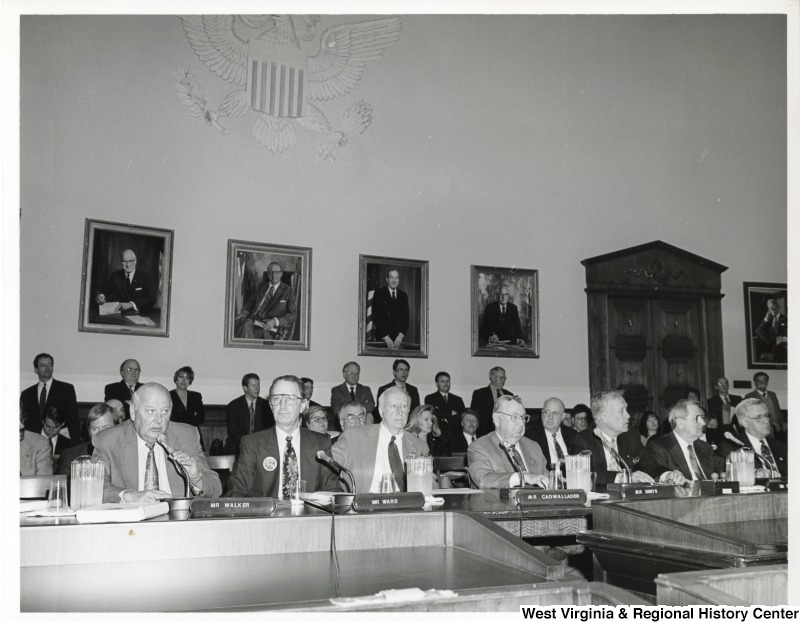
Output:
[{"xmin": 470, "ymin": 266, "xmax": 539, "ymax": 358}]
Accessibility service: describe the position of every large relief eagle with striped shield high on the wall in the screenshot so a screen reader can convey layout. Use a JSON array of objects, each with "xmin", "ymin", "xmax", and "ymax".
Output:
[{"xmin": 175, "ymin": 15, "xmax": 401, "ymax": 161}]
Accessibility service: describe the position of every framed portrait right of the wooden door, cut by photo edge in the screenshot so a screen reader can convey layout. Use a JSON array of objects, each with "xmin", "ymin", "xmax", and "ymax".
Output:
[{"xmin": 744, "ymin": 282, "xmax": 789, "ymax": 369}]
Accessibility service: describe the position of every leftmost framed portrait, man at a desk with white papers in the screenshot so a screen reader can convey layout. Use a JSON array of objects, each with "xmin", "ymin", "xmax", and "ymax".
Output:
[{"xmin": 78, "ymin": 218, "xmax": 174, "ymax": 337}]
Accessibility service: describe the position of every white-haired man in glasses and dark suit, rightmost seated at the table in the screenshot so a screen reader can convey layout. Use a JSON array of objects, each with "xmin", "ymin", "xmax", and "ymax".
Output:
[{"xmin": 724, "ymin": 397, "xmax": 789, "ymax": 477}]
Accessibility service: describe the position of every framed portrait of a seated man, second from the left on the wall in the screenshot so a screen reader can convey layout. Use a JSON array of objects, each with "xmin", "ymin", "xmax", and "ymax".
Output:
[{"xmin": 225, "ymin": 240, "xmax": 311, "ymax": 350}]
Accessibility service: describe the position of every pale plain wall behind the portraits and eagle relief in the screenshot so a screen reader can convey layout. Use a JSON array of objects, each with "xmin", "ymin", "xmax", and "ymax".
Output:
[{"xmin": 20, "ymin": 15, "xmax": 787, "ymax": 406}]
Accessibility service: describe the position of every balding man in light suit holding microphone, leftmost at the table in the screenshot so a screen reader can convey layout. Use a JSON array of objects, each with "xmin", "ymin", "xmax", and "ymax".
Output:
[{"xmin": 92, "ymin": 382, "xmax": 222, "ymax": 503}]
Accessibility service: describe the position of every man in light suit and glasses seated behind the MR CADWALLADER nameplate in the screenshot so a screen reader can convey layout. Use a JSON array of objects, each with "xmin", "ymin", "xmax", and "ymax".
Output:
[{"xmin": 467, "ymin": 395, "xmax": 548, "ymax": 488}]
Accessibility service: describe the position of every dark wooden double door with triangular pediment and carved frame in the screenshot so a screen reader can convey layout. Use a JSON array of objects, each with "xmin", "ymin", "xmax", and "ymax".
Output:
[{"xmin": 581, "ymin": 241, "xmax": 727, "ymax": 419}]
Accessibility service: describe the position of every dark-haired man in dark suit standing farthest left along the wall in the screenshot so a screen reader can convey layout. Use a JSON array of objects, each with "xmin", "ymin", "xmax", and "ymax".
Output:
[{"xmin": 20, "ymin": 352, "xmax": 80, "ymax": 442}]
